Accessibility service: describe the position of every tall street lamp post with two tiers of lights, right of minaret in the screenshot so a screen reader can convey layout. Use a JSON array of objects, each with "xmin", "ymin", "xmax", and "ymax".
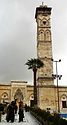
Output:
[{"xmin": 51, "ymin": 59, "xmax": 62, "ymax": 113}]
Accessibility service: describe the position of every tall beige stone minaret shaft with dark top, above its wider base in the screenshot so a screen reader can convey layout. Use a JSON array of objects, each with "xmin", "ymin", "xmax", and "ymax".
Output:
[{"xmin": 35, "ymin": 4, "xmax": 54, "ymax": 85}]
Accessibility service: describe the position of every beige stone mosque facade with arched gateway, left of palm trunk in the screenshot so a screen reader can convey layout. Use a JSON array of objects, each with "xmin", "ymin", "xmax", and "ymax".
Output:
[{"xmin": 0, "ymin": 80, "xmax": 34, "ymax": 106}]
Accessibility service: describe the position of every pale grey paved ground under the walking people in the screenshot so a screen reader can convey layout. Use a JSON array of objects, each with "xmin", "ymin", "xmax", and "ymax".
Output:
[{"xmin": 0, "ymin": 112, "xmax": 41, "ymax": 125}]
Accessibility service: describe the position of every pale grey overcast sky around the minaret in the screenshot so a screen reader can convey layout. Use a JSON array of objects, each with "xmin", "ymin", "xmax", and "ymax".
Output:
[{"xmin": 0, "ymin": 0, "xmax": 67, "ymax": 85}]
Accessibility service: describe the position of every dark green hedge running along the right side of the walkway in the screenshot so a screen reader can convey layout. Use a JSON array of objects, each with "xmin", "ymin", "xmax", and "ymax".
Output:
[{"xmin": 30, "ymin": 107, "xmax": 67, "ymax": 125}]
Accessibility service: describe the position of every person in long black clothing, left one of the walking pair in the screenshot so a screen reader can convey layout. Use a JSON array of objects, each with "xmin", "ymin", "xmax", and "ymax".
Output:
[{"xmin": 6, "ymin": 101, "xmax": 14, "ymax": 122}]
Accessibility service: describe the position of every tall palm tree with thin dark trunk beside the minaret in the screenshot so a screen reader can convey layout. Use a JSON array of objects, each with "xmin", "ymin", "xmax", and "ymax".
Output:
[{"xmin": 26, "ymin": 58, "xmax": 44, "ymax": 105}]
